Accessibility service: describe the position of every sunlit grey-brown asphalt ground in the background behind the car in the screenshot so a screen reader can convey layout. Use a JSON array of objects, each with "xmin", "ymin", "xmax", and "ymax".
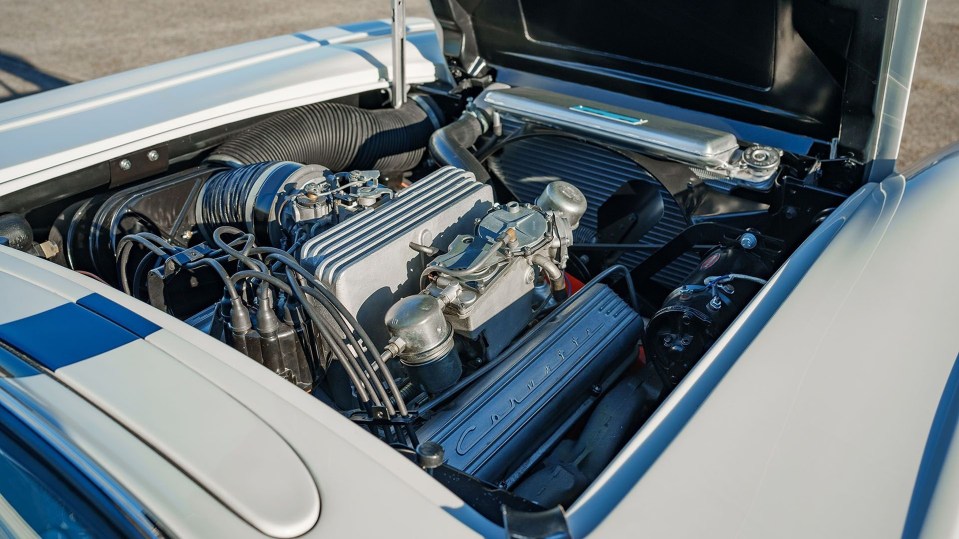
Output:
[{"xmin": 0, "ymin": 0, "xmax": 959, "ymax": 165}]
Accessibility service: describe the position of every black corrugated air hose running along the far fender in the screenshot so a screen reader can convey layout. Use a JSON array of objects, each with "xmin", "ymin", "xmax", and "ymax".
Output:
[{"xmin": 208, "ymin": 101, "xmax": 436, "ymax": 172}]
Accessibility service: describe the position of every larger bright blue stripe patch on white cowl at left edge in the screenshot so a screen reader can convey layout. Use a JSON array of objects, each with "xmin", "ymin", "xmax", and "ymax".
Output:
[{"xmin": 0, "ymin": 303, "xmax": 138, "ymax": 370}]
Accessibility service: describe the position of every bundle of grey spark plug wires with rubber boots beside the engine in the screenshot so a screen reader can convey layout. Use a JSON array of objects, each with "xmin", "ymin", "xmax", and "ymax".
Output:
[{"xmin": 117, "ymin": 226, "xmax": 417, "ymax": 447}]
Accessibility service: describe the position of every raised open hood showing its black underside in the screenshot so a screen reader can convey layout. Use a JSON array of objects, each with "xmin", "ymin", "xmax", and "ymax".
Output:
[{"xmin": 431, "ymin": 0, "xmax": 924, "ymax": 165}]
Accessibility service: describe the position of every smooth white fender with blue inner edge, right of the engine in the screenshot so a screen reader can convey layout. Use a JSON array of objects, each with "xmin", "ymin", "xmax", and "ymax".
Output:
[{"xmin": 570, "ymin": 146, "xmax": 959, "ymax": 537}]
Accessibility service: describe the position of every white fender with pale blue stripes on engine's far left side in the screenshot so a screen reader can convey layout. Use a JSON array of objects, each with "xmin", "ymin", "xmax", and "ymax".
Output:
[{"xmin": 0, "ymin": 18, "xmax": 448, "ymax": 196}]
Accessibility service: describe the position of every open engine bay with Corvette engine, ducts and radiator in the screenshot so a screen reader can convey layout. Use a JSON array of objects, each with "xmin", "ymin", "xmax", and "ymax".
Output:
[{"xmin": 0, "ymin": 79, "xmax": 861, "ymax": 521}]
